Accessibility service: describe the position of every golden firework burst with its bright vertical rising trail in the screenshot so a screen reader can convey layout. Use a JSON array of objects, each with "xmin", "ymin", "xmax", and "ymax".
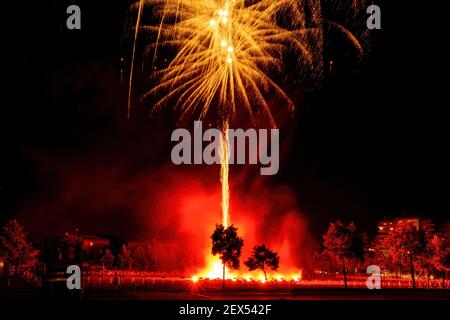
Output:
[{"xmin": 128, "ymin": 0, "xmax": 366, "ymax": 226}]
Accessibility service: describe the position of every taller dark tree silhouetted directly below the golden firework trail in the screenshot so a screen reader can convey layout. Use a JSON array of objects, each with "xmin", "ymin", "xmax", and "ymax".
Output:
[{"xmin": 211, "ymin": 224, "xmax": 244, "ymax": 288}]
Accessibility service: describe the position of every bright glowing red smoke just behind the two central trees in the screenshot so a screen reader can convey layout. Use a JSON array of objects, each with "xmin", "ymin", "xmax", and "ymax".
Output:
[{"xmin": 141, "ymin": 167, "xmax": 312, "ymax": 273}]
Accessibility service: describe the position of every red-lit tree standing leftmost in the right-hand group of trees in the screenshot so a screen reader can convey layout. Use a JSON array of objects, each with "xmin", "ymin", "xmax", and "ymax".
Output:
[{"xmin": 323, "ymin": 220, "xmax": 364, "ymax": 288}]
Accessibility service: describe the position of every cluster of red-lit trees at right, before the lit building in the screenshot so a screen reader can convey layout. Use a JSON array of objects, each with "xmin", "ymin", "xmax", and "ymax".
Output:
[{"xmin": 315, "ymin": 221, "xmax": 450, "ymax": 288}]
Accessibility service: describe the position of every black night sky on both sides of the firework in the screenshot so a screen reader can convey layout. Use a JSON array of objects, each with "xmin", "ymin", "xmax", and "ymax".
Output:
[{"xmin": 0, "ymin": 0, "xmax": 450, "ymax": 237}]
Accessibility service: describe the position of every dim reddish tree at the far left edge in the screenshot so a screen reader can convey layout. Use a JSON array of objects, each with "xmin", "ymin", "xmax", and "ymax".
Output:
[{"xmin": 0, "ymin": 220, "xmax": 38, "ymax": 284}]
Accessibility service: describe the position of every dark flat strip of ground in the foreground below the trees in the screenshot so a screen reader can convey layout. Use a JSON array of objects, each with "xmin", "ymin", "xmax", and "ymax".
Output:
[{"xmin": 0, "ymin": 283, "xmax": 450, "ymax": 301}]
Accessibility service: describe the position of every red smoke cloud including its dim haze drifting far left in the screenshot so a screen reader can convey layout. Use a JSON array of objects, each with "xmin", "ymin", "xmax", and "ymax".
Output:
[{"xmin": 22, "ymin": 154, "xmax": 312, "ymax": 275}]
